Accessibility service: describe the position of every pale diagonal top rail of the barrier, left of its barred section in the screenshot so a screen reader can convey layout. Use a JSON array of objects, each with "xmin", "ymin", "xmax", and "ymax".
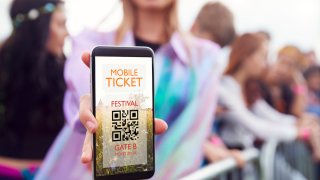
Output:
[{"xmin": 182, "ymin": 148, "xmax": 259, "ymax": 180}]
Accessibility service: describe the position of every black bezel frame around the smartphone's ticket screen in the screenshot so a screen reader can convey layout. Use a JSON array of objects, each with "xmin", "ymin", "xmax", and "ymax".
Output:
[{"xmin": 90, "ymin": 46, "xmax": 155, "ymax": 180}]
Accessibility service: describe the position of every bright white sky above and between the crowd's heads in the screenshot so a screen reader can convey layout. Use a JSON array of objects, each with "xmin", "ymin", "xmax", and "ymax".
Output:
[{"xmin": 0, "ymin": 0, "xmax": 320, "ymax": 55}]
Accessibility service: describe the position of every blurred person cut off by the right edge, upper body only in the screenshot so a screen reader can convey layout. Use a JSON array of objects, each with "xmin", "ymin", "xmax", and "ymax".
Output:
[{"xmin": 304, "ymin": 65, "xmax": 320, "ymax": 117}]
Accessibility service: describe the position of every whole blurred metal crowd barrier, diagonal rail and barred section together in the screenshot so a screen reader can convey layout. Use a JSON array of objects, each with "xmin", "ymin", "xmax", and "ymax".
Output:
[{"xmin": 182, "ymin": 141, "xmax": 317, "ymax": 180}]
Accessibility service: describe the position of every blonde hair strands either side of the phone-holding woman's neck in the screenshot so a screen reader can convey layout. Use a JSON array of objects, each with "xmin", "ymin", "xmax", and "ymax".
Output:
[{"xmin": 115, "ymin": 0, "xmax": 180, "ymax": 45}]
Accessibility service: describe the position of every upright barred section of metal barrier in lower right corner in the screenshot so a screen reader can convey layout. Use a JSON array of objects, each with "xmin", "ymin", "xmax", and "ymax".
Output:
[{"xmin": 260, "ymin": 141, "xmax": 316, "ymax": 180}]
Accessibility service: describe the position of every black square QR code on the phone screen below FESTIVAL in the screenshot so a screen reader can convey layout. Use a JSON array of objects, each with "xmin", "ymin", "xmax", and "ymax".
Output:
[{"xmin": 112, "ymin": 110, "xmax": 139, "ymax": 141}]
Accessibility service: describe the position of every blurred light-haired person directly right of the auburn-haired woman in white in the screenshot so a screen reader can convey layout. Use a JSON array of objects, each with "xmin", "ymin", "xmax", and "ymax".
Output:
[{"xmin": 265, "ymin": 46, "xmax": 307, "ymax": 117}]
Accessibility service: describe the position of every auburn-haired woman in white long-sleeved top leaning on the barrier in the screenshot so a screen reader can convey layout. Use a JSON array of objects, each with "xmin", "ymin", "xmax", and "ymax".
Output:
[{"xmin": 219, "ymin": 33, "xmax": 319, "ymax": 158}]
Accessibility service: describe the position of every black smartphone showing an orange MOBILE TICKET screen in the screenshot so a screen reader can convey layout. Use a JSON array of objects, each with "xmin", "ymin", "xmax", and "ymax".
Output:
[{"xmin": 90, "ymin": 46, "xmax": 155, "ymax": 180}]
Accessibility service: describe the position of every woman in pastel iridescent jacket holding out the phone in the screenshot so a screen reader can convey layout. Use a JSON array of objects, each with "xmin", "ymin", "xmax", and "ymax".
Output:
[{"xmin": 37, "ymin": 0, "xmax": 219, "ymax": 179}]
